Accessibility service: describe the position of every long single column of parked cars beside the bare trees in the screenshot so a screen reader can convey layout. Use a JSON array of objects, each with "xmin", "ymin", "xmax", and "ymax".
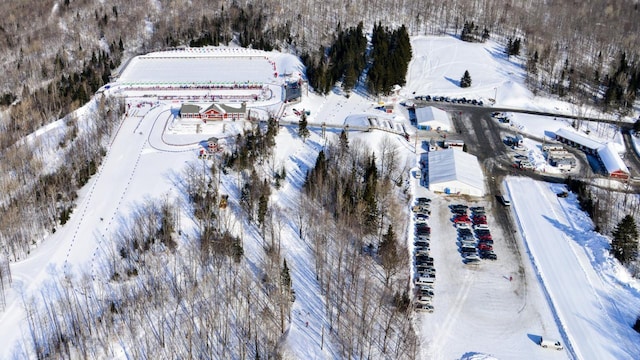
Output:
[{"xmin": 412, "ymin": 197, "xmax": 436, "ymax": 313}]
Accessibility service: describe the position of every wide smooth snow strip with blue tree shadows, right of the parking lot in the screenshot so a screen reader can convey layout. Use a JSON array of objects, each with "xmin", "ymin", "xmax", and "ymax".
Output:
[{"xmin": 506, "ymin": 178, "xmax": 640, "ymax": 359}]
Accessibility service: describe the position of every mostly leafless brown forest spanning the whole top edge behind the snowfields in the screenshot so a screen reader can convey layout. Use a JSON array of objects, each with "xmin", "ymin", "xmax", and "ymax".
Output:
[{"xmin": 0, "ymin": 0, "xmax": 640, "ymax": 116}]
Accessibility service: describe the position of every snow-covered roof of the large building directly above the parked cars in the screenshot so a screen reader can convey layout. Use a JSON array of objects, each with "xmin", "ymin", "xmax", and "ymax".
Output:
[{"xmin": 429, "ymin": 149, "xmax": 484, "ymax": 193}]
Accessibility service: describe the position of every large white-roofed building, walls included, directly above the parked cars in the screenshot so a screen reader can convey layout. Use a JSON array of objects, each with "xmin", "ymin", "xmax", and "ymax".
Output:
[{"xmin": 429, "ymin": 149, "xmax": 485, "ymax": 197}]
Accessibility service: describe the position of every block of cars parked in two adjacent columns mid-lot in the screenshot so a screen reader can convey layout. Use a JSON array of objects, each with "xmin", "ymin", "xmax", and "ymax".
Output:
[{"xmin": 450, "ymin": 204, "xmax": 498, "ymax": 264}]
